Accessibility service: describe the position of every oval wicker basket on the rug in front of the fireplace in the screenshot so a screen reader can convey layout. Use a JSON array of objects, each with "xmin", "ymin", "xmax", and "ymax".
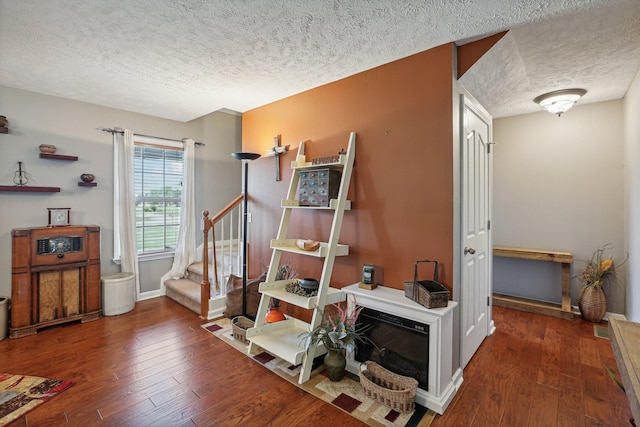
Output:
[{"xmin": 358, "ymin": 360, "xmax": 418, "ymax": 413}]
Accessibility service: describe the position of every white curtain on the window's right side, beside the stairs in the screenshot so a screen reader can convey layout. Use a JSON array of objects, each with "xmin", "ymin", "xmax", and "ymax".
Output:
[{"xmin": 160, "ymin": 139, "xmax": 196, "ymax": 294}]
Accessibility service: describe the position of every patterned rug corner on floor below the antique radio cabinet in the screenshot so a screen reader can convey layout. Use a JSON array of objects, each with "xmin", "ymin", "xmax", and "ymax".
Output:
[{"xmin": 0, "ymin": 373, "xmax": 75, "ymax": 426}]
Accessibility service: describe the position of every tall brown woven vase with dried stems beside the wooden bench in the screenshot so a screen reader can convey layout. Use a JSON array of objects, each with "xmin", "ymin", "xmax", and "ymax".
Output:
[{"xmin": 578, "ymin": 243, "xmax": 628, "ymax": 322}]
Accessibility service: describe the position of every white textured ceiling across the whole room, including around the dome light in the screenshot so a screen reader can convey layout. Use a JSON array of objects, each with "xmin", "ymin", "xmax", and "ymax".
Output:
[{"xmin": 0, "ymin": 0, "xmax": 640, "ymax": 121}]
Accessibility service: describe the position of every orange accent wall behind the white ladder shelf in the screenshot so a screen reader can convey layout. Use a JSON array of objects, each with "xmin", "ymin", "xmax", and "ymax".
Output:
[{"xmin": 242, "ymin": 44, "xmax": 455, "ymax": 314}]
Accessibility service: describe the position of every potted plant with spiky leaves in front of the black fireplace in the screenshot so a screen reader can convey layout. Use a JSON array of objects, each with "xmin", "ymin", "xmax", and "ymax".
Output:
[{"xmin": 301, "ymin": 297, "xmax": 368, "ymax": 381}]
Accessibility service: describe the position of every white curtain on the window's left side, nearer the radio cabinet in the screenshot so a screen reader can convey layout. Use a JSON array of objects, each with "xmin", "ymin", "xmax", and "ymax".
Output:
[{"xmin": 113, "ymin": 129, "xmax": 140, "ymax": 300}]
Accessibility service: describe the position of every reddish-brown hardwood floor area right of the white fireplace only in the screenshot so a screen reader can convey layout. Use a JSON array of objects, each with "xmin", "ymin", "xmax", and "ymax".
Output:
[{"xmin": 432, "ymin": 307, "xmax": 631, "ymax": 427}]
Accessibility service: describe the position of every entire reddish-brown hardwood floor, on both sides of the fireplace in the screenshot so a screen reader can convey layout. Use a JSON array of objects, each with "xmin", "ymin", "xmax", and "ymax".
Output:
[{"xmin": 0, "ymin": 297, "xmax": 631, "ymax": 427}]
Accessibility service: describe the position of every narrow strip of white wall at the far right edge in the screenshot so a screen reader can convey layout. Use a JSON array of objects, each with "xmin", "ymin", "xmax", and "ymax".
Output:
[{"xmin": 624, "ymin": 71, "xmax": 640, "ymax": 322}]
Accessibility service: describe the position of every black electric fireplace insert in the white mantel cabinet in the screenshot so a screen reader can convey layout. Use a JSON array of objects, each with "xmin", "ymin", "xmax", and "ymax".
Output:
[{"xmin": 355, "ymin": 307, "xmax": 429, "ymax": 390}]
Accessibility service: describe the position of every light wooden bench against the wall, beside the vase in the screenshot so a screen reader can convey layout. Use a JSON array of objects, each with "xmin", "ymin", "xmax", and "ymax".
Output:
[{"xmin": 493, "ymin": 246, "xmax": 573, "ymax": 320}]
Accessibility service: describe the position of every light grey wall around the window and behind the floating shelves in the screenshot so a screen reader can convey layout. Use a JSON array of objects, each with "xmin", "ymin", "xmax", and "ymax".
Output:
[{"xmin": 0, "ymin": 86, "xmax": 241, "ymax": 296}]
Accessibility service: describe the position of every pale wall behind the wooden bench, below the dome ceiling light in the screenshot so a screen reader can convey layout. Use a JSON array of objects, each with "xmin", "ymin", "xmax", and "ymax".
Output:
[{"xmin": 492, "ymin": 100, "xmax": 625, "ymax": 313}]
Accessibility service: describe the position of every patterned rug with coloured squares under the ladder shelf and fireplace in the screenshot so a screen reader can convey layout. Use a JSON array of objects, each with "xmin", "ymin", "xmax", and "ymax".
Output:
[{"xmin": 202, "ymin": 318, "xmax": 436, "ymax": 427}]
